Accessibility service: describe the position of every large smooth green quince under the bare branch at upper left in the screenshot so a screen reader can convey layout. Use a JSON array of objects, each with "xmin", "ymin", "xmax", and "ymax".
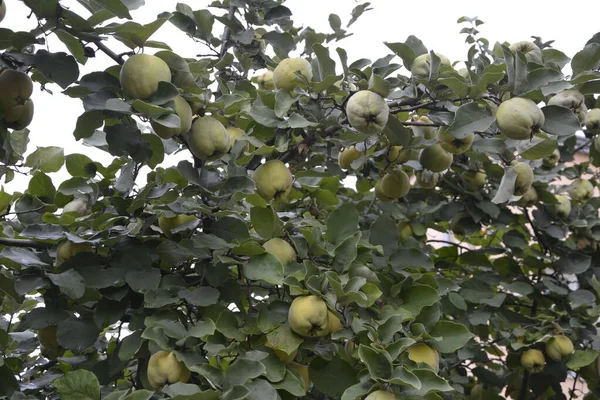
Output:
[{"xmin": 119, "ymin": 54, "xmax": 171, "ymax": 100}]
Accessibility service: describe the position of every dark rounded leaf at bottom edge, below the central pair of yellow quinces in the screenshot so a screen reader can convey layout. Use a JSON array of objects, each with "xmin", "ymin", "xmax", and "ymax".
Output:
[{"xmin": 308, "ymin": 357, "xmax": 358, "ymax": 399}]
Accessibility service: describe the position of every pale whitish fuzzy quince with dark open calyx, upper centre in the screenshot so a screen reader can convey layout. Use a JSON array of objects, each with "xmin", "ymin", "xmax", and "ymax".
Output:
[{"xmin": 346, "ymin": 90, "xmax": 390, "ymax": 135}]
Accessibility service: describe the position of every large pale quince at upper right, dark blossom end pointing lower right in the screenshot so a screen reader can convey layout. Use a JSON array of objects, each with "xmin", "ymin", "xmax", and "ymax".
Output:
[{"xmin": 496, "ymin": 97, "xmax": 545, "ymax": 140}]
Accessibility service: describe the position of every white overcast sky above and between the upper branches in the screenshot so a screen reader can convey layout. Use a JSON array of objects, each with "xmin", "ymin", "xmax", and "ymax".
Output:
[{"xmin": 0, "ymin": 0, "xmax": 600, "ymax": 191}]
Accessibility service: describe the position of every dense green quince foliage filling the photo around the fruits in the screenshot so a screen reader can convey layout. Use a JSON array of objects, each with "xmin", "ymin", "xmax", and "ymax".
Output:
[{"xmin": 0, "ymin": 0, "xmax": 600, "ymax": 400}]
